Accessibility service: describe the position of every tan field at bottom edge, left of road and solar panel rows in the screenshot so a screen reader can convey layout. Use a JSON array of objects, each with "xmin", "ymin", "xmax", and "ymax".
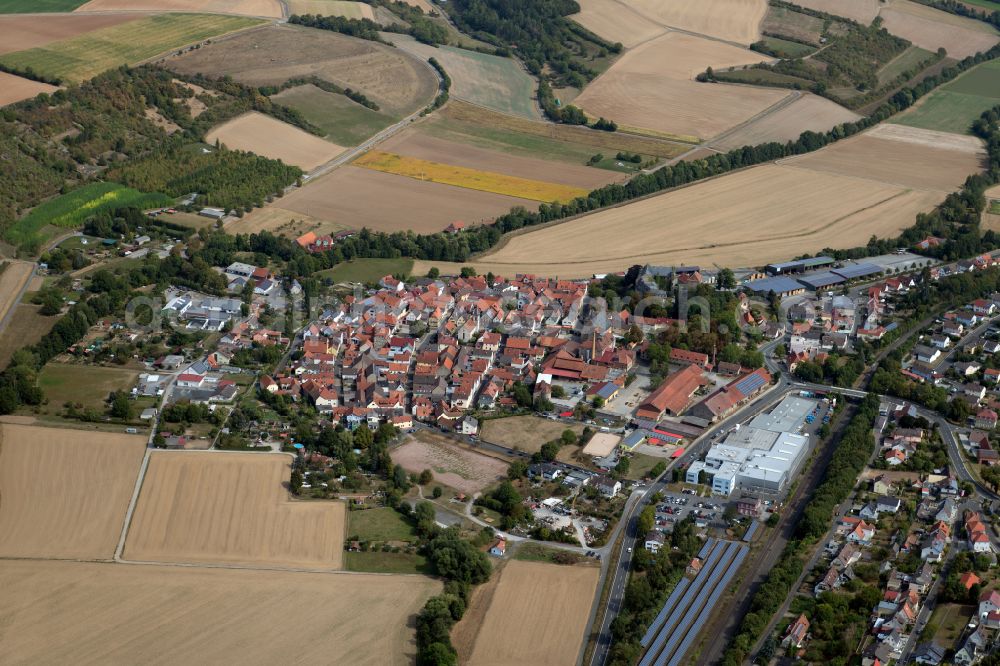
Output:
[{"xmin": 455, "ymin": 560, "xmax": 601, "ymax": 666}]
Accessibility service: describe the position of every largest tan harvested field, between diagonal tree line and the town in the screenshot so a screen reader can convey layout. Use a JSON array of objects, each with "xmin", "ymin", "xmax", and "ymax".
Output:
[{"xmin": 414, "ymin": 127, "xmax": 982, "ymax": 277}]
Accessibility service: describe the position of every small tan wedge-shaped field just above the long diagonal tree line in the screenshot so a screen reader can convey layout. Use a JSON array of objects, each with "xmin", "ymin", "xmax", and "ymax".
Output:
[{"xmin": 712, "ymin": 93, "xmax": 861, "ymax": 150}]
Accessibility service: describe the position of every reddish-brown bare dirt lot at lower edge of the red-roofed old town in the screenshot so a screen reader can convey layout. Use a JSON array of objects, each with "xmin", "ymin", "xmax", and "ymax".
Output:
[{"xmin": 391, "ymin": 431, "xmax": 509, "ymax": 495}]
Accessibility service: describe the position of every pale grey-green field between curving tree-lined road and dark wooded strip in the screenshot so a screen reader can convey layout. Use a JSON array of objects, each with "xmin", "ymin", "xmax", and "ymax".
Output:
[{"xmin": 389, "ymin": 35, "xmax": 541, "ymax": 120}]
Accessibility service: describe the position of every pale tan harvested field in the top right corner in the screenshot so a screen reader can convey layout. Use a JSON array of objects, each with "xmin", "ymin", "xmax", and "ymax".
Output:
[{"xmin": 879, "ymin": 0, "xmax": 1000, "ymax": 59}]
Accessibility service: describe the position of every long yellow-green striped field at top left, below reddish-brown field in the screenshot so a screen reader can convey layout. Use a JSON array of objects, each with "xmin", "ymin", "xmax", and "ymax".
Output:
[{"xmin": 0, "ymin": 14, "xmax": 264, "ymax": 82}]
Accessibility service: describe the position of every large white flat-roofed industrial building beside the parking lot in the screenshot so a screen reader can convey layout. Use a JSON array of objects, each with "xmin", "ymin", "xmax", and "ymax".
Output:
[{"xmin": 686, "ymin": 396, "xmax": 819, "ymax": 496}]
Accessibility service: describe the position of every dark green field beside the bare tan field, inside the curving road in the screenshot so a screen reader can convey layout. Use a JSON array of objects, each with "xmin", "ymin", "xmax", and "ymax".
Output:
[{"xmin": 271, "ymin": 85, "xmax": 397, "ymax": 146}]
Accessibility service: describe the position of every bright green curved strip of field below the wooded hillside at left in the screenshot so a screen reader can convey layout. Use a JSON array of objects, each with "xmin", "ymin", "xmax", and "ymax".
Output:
[{"xmin": 4, "ymin": 183, "xmax": 173, "ymax": 249}]
